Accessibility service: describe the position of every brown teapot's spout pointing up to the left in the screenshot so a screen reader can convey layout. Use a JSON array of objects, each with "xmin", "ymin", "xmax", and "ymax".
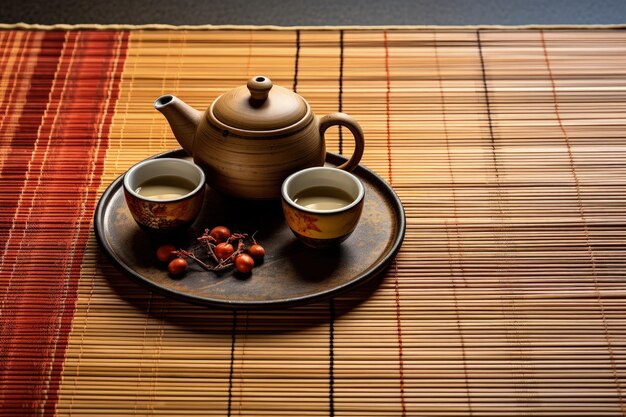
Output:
[{"xmin": 154, "ymin": 94, "xmax": 203, "ymax": 155}]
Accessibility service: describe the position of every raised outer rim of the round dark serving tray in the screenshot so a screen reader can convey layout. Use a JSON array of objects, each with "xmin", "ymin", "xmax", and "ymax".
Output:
[{"xmin": 93, "ymin": 148, "xmax": 406, "ymax": 310}]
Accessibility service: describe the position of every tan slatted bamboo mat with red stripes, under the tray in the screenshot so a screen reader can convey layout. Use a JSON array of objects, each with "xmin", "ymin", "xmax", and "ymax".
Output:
[{"xmin": 0, "ymin": 28, "xmax": 626, "ymax": 416}]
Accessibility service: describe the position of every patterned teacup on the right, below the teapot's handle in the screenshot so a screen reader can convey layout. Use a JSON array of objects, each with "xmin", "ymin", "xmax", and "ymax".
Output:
[{"xmin": 281, "ymin": 167, "xmax": 365, "ymax": 248}]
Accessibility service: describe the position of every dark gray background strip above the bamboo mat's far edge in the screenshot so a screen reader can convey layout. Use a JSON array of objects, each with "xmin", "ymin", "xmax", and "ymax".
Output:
[{"xmin": 0, "ymin": 0, "xmax": 626, "ymax": 26}]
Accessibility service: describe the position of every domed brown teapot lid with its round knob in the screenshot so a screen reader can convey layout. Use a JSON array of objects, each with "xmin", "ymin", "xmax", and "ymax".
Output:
[{"xmin": 211, "ymin": 75, "xmax": 308, "ymax": 131}]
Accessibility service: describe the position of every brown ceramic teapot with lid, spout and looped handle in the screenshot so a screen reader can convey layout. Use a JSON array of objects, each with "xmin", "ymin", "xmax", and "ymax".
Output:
[{"xmin": 154, "ymin": 76, "xmax": 364, "ymax": 200}]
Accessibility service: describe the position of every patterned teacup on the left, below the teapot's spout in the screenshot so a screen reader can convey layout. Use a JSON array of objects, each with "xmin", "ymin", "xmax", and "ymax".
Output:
[{"xmin": 124, "ymin": 158, "xmax": 205, "ymax": 235}]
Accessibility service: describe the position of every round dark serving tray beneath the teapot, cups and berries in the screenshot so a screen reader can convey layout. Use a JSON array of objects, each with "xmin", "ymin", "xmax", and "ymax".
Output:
[{"xmin": 94, "ymin": 150, "xmax": 406, "ymax": 309}]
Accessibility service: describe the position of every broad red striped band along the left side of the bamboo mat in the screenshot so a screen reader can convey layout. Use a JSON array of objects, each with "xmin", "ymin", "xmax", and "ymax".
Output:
[{"xmin": 0, "ymin": 31, "xmax": 128, "ymax": 415}]
